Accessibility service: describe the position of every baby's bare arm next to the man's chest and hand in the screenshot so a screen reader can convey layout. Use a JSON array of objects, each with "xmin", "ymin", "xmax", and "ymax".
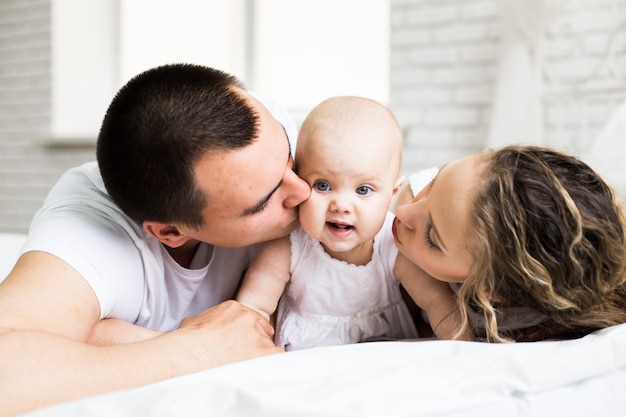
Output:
[{"xmin": 237, "ymin": 236, "xmax": 291, "ymax": 320}]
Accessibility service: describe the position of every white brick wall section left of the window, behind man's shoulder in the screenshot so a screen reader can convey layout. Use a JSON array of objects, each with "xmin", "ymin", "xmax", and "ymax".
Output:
[{"xmin": 0, "ymin": 0, "xmax": 94, "ymax": 232}]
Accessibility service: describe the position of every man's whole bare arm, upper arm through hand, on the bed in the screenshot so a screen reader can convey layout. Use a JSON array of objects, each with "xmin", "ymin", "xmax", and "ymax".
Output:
[{"xmin": 0, "ymin": 252, "xmax": 282, "ymax": 415}]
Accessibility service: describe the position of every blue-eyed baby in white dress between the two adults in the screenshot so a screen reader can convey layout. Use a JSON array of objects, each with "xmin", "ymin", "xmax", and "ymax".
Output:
[{"xmin": 237, "ymin": 97, "xmax": 417, "ymax": 350}]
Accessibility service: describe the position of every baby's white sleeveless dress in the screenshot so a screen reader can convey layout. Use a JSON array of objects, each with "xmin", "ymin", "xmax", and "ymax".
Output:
[{"xmin": 275, "ymin": 213, "xmax": 418, "ymax": 350}]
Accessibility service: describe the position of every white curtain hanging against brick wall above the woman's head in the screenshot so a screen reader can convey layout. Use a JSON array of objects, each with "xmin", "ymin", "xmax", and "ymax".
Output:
[{"xmin": 486, "ymin": 0, "xmax": 568, "ymax": 147}]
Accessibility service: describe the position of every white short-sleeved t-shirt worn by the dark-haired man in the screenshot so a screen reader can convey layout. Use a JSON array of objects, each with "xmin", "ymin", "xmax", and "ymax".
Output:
[{"xmin": 21, "ymin": 95, "xmax": 296, "ymax": 331}]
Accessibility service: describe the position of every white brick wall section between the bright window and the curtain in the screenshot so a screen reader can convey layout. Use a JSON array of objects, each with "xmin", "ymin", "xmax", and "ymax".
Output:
[{"xmin": 390, "ymin": 0, "xmax": 497, "ymax": 173}]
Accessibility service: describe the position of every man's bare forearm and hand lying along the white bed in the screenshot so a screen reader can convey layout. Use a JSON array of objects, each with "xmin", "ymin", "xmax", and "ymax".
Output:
[{"xmin": 0, "ymin": 301, "xmax": 283, "ymax": 416}]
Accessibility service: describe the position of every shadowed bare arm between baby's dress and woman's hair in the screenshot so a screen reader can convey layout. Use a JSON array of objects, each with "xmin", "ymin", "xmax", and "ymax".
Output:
[{"xmin": 394, "ymin": 254, "xmax": 470, "ymax": 340}]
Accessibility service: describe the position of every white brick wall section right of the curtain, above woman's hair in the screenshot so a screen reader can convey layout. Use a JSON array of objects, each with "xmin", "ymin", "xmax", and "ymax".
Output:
[{"xmin": 544, "ymin": 0, "xmax": 626, "ymax": 154}]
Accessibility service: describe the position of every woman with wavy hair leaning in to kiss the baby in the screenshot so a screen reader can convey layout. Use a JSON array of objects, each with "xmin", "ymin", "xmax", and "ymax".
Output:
[{"xmin": 394, "ymin": 146, "xmax": 626, "ymax": 342}]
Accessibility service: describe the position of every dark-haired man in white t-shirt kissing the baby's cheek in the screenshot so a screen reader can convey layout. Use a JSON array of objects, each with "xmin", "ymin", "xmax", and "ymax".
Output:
[{"xmin": 0, "ymin": 65, "xmax": 310, "ymax": 415}]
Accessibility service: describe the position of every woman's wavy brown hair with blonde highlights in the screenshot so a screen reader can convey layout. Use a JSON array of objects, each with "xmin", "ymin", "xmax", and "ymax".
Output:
[{"xmin": 457, "ymin": 146, "xmax": 626, "ymax": 342}]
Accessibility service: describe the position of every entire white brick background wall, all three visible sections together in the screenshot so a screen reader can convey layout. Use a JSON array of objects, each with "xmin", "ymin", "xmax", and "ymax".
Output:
[{"xmin": 0, "ymin": 0, "xmax": 626, "ymax": 232}]
